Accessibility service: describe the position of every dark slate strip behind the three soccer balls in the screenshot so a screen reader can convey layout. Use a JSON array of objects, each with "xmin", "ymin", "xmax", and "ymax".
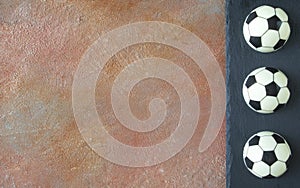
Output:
[{"xmin": 226, "ymin": 0, "xmax": 300, "ymax": 188}]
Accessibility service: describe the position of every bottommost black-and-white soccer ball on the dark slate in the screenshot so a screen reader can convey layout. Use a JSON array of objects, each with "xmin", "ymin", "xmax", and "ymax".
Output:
[{"xmin": 243, "ymin": 131, "xmax": 292, "ymax": 178}]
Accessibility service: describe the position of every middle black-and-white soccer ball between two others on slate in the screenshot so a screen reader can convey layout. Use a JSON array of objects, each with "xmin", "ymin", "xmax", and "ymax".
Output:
[{"xmin": 242, "ymin": 67, "xmax": 290, "ymax": 114}]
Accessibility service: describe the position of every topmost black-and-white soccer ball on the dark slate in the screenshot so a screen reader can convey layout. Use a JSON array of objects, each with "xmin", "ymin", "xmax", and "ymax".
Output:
[{"xmin": 243, "ymin": 5, "xmax": 291, "ymax": 53}]
